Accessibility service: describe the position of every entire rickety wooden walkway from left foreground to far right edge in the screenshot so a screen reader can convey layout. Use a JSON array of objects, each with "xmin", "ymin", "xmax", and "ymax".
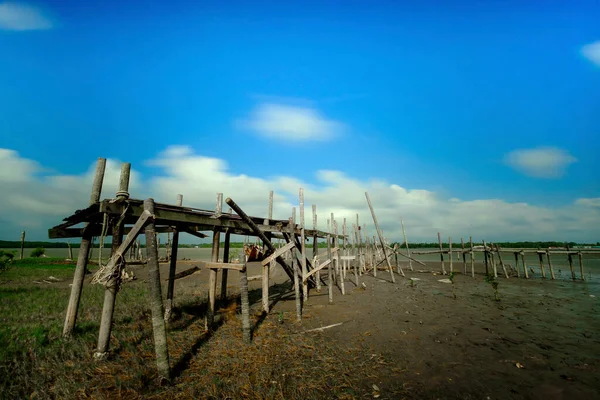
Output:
[{"xmin": 48, "ymin": 158, "xmax": 599, "ymax": 380}]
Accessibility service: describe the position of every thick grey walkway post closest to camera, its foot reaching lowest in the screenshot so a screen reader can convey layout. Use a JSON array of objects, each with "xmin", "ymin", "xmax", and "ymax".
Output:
[{"xmin": 144, "ymin": 199, "xmax": 171, "ymax": 381}]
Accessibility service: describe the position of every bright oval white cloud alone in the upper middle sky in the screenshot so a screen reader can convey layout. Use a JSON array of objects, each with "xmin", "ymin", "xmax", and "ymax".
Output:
[{"xmin": 238, "ymin": 103, "xmax": 344, "ymax": 142}]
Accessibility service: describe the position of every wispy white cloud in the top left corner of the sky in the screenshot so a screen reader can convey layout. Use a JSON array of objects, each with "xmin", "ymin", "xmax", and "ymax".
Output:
[{"xmin": 0, "ymin": 2, "xmax": 53, "ymax": 31}]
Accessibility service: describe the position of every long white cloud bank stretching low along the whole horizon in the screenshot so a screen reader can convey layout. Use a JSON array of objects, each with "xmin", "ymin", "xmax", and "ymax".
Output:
[{"xmin": 0, "ymin": 146, "xmax": 600, "ymax": 242}]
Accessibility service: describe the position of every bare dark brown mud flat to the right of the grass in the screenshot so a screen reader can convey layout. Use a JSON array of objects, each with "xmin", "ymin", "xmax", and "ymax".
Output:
[{"xmin": 113, "ymin": 256, "xmax": 600, "ymax": 399}]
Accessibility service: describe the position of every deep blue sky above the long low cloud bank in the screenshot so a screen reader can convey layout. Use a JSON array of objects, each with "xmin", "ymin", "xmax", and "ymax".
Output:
[{"xmin": 0, "ymin": 1, "xmax": 600, "ymax": 241}]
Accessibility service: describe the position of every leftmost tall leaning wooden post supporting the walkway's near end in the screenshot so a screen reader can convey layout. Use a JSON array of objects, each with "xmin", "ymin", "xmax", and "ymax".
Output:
[{"xmin": 63, "ymin": 158, "xmax": 106, "ymax": 337}]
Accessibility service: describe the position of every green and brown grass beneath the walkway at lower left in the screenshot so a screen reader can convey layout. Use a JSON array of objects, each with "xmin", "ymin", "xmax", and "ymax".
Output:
[{"xmin": 0, "ymin": 259, "xmax": 376, "ymax": 399}]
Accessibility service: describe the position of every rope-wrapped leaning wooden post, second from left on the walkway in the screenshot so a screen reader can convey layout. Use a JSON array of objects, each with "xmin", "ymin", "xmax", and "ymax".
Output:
[{"xmin": 94, "ymin": 163, "xmax": 130, "ymax": 359}]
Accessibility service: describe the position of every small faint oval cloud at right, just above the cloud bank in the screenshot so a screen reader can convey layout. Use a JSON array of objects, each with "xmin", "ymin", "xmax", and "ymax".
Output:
[{"xmin": 504, "ymin": 147, "xmax": 577, "ymax": 178}]
